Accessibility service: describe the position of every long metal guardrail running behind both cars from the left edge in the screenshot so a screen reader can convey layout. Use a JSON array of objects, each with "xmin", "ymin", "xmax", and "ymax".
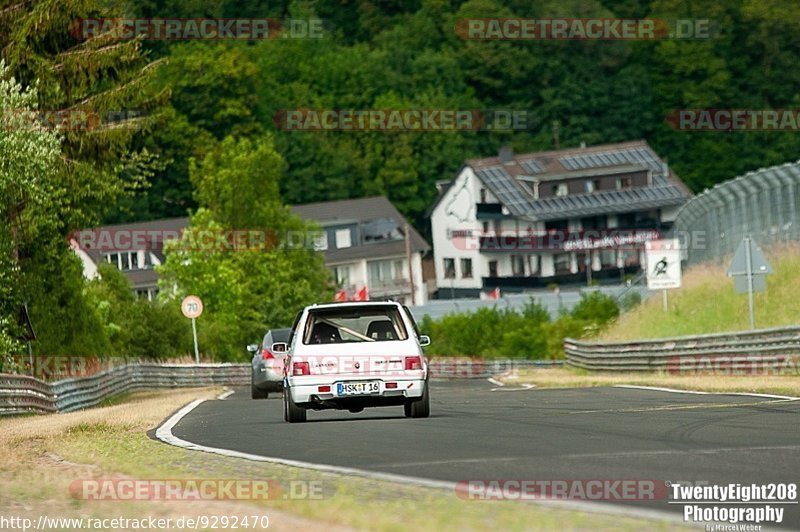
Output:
[{"xmin": 0, "ymin": 357, "xmax": 563, "ymax": 415}]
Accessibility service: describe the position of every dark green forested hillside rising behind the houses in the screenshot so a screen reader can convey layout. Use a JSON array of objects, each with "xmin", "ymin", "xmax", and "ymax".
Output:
[{"xmin": 119, "ymin": 0, "xmax": 800, "ymax": 227}]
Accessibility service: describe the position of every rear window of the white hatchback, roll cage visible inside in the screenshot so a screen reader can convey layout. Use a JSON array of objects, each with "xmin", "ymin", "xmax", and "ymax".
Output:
[{"xmin": 303, "ymin": 306, "xmax": 408, "ymax": 344}]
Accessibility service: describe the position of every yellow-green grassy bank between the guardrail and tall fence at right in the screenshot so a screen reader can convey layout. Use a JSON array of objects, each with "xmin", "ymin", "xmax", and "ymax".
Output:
[{"xmin": 597, "ymin": 246, "xmax": 800, "ymax": 341}]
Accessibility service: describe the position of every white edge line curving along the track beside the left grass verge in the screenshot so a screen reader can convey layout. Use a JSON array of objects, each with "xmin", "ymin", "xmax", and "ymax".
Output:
[{"xmin": 156, "ymin": 399, "xmax": 685, "ymax": 524}]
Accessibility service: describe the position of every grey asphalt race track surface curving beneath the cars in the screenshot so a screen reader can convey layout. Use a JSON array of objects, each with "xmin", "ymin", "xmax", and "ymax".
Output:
[{"xmin": 173, "ymin": 380, "xmax": 800, "ymax": 529}]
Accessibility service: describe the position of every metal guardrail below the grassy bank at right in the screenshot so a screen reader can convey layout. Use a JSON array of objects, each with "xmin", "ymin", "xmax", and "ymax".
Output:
[{"xmin": 564, "ymin": 326, "xmax": 800, "ymax": 371}]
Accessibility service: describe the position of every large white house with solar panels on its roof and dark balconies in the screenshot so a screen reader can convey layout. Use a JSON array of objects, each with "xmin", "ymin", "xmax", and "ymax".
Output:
[{"xmin": 430, "ymin": 140, "xmax": 691, "ymax": 298}]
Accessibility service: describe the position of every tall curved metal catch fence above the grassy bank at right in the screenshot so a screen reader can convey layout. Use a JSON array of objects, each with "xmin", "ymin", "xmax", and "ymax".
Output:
[{"xmin": 674, "ymin": 161, "xmax": 800, "ymax": 264}]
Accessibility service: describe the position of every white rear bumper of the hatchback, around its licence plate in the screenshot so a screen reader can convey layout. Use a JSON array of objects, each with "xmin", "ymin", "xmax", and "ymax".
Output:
[{"xmin": 287, "ymin": 377, "xmax": 425, "ymax": 409}]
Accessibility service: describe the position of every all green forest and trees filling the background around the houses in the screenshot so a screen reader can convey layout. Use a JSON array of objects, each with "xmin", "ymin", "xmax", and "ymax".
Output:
[{"xmin": 0, "ymin": 0, "xmax": 800, "ymax": 358}]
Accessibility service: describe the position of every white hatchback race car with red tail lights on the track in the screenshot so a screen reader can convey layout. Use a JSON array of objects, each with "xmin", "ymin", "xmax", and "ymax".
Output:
[{"xmin": 272, "ymin": 301, "xmax": 430, "ymax": 423}]
